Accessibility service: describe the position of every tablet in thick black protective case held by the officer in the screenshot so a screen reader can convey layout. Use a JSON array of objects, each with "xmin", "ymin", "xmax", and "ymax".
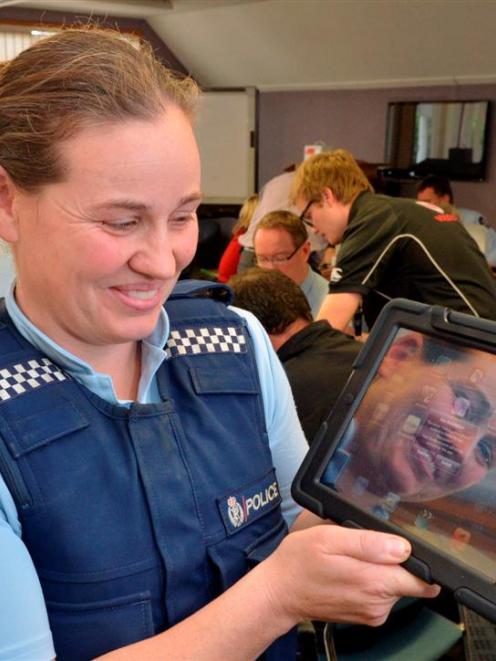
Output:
[{"xmin": 293, "ymin": 299, "xmax": 496, "ymax": 621}]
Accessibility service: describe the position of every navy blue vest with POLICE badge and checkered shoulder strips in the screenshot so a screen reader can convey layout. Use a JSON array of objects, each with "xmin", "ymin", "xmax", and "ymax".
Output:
[{"xmin": 0, "ymin": 281, "xmax": 295, "ymax": 661}]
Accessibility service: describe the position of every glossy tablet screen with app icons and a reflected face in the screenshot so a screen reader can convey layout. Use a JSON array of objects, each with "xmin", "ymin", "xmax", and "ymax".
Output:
[{"xmin": 320, "ymin": 329, "xmax": 496, "ymax": 582}]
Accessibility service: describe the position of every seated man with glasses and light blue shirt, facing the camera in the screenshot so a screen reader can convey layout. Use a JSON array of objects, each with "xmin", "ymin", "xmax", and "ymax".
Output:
[{"xmin": 253, "ymin": 211, "xmax": 329, "ymax": 318}]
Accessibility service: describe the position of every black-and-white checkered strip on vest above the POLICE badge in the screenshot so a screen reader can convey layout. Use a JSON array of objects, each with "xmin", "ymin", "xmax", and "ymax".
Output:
[{"xmin": 166, "ymin": 326, "xmax": 246, "ymax": 357}]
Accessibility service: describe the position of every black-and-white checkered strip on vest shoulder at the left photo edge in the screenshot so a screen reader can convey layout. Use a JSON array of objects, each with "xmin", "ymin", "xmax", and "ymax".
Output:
[{"xmin": 0, "ymin": 358, "xmax": 67, "ymax": 404}]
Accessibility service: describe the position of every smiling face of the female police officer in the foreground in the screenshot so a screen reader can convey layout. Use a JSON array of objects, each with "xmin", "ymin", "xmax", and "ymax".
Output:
[{"xmin": 4, "ymin": 106, "xmax": 200, "ymax": 358}]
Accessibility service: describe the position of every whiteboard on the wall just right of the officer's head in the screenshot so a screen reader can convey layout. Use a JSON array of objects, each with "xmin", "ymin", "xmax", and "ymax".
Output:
[{"xmin": 195, "ymin": 88, "xmax": 257, "ymax": 204}]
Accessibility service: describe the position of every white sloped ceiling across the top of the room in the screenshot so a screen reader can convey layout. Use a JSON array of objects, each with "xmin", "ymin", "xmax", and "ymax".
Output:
[{"xmin": 0, "ymin": 0, "xmax": 496, "ymax": 90}]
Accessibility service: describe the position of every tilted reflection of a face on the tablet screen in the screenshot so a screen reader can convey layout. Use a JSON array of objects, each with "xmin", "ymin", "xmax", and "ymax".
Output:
[{"xmin": 328, "ymin": 331, "xmax": 496, "ymax": 501}]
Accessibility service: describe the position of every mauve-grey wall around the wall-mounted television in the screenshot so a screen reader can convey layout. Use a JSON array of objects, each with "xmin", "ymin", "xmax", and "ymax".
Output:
[{"xmin": 259, "ymin": 85, "xmax": 496, "ymax": 226}]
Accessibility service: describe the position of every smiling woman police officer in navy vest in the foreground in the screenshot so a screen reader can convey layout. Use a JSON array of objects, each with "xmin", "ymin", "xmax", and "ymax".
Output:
[{"xmin": 0, "ymin": 29, "xmax": 438, "ymax": 661}]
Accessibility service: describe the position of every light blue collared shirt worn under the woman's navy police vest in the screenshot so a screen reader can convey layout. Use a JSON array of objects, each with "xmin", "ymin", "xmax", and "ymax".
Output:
[{"xmin": 0, "ymin": 286, "xmax": 308, "ymax": 661}]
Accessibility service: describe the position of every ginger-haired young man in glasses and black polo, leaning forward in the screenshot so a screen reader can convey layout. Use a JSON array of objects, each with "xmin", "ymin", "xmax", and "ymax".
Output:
[{"xmin": 292, "ymin": 149, "xmax": 496, "ymax": 330}]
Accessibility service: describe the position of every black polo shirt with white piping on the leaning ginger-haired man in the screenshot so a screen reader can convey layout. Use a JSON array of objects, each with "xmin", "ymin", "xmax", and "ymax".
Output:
[{"xmin": 329, "ymin": 192, "xmax": 496, "ymax": 327}]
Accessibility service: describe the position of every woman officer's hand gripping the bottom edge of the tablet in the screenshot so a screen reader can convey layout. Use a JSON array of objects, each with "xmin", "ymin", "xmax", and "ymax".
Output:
[{"xmin": 258, "ymin": 526, "xmax": 439, "ymax": 628}]
